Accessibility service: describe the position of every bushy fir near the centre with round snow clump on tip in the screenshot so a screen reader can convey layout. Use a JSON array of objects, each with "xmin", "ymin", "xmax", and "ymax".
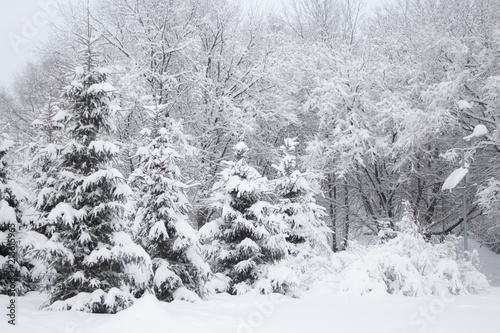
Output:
[{"xmin": 200, "ymin": 142, "xmax": 287, "ymax": 294}]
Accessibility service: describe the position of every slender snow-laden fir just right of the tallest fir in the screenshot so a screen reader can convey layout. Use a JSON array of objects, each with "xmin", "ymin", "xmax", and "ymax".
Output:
[{"xmin": 130, "ymin": 117, "xmax": 210, "ymax": 301}]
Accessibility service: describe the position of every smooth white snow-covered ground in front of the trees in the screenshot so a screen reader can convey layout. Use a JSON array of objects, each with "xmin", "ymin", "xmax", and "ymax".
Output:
[{"xmin": 0, "ymin": 237, "xmax": 500, "ymax": 333}]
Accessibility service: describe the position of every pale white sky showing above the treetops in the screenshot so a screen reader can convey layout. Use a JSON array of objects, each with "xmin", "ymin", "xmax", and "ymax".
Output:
[{"xmin": 0, "ymin": 0, "xmax": 383, "ymax": 87}]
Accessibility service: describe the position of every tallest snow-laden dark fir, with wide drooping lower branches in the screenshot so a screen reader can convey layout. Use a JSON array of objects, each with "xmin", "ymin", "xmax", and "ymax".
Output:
[{"xmin": 31, "ymin": 65, "xmax": 147, "ymax": 313}]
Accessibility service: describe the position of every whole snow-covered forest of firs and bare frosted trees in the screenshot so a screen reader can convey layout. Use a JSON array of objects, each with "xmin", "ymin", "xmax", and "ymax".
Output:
[{"xmin": 0, "ymin": 0, "xmax": 500, "ymax": 332}]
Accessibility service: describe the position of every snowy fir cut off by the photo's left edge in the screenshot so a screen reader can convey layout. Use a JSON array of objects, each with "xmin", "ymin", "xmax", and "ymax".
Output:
[{"xmin": 0, "ymin": 136, "xmax": 34, "ymax": 296}]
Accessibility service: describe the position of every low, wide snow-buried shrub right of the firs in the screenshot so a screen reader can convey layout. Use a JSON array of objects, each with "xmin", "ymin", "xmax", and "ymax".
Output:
[{"xmin": 336, "ymin": 201, "xmax": 488, "ymax": 296}]
